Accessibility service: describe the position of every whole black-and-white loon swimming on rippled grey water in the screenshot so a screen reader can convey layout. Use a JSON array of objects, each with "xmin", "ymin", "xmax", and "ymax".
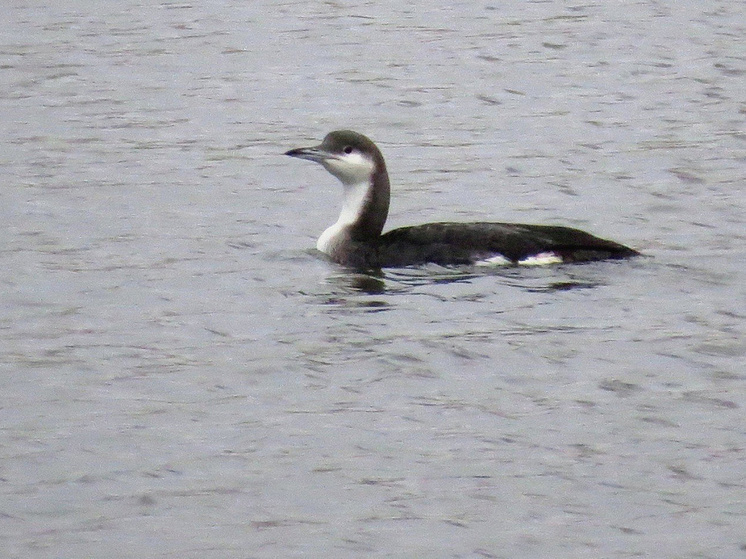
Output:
[{"xmin": 285, "ymin": 130, "xmax": 639, "ymax": 269}]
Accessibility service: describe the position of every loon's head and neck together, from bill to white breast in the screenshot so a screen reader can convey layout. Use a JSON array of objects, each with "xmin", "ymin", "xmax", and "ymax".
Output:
[{"xmin": 285, "ymin": 130, "xmax": 390, "ymax": 253}]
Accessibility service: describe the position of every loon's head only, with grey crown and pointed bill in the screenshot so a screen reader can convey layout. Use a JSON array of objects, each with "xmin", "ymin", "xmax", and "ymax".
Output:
[{"xmin": 285, "ymin": 130, "xmax": 386, "ymax": 186}]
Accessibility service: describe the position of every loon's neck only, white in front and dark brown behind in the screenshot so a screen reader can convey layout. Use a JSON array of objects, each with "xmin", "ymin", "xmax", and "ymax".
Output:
[{"xmin": 316, "ymin": 166, "xmax": 391, "ymax": 255}]
